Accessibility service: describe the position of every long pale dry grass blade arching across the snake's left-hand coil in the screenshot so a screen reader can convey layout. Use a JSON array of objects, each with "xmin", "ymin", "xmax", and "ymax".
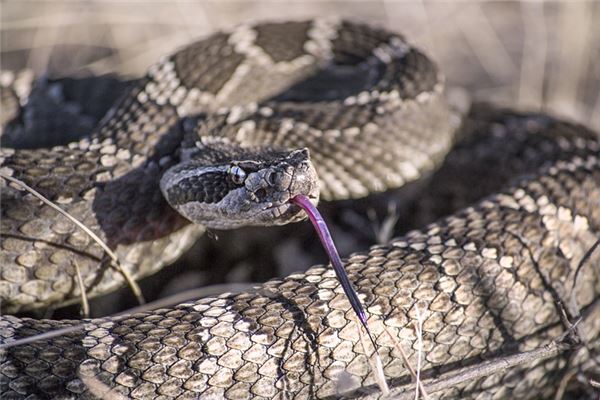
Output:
[{"xmin": 0, "ymin": 172, "xmax": 146, "ymax": 304}]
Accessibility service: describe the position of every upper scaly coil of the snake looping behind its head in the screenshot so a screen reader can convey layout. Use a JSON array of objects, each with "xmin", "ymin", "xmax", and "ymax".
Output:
[{"xmin": 0, "ymin": 21, "xmax": 460, "ymax": 312}]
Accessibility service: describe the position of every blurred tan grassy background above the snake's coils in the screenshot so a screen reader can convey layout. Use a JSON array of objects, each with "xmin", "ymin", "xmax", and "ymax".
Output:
[{"xmin": 0, "ymin": 0, "xmax": 600, "ymax": 128}]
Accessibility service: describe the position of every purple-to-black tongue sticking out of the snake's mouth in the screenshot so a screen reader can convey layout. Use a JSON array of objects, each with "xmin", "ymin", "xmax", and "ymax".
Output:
[{"xmin": 291, "ymin": 195, "xmax": 376, "ymax": 332}]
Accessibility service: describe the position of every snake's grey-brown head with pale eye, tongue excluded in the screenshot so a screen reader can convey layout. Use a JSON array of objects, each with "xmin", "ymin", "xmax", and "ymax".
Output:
[{"xmin": 160, "ymin": 146, "xmax": 319, "ymax": 229}]
